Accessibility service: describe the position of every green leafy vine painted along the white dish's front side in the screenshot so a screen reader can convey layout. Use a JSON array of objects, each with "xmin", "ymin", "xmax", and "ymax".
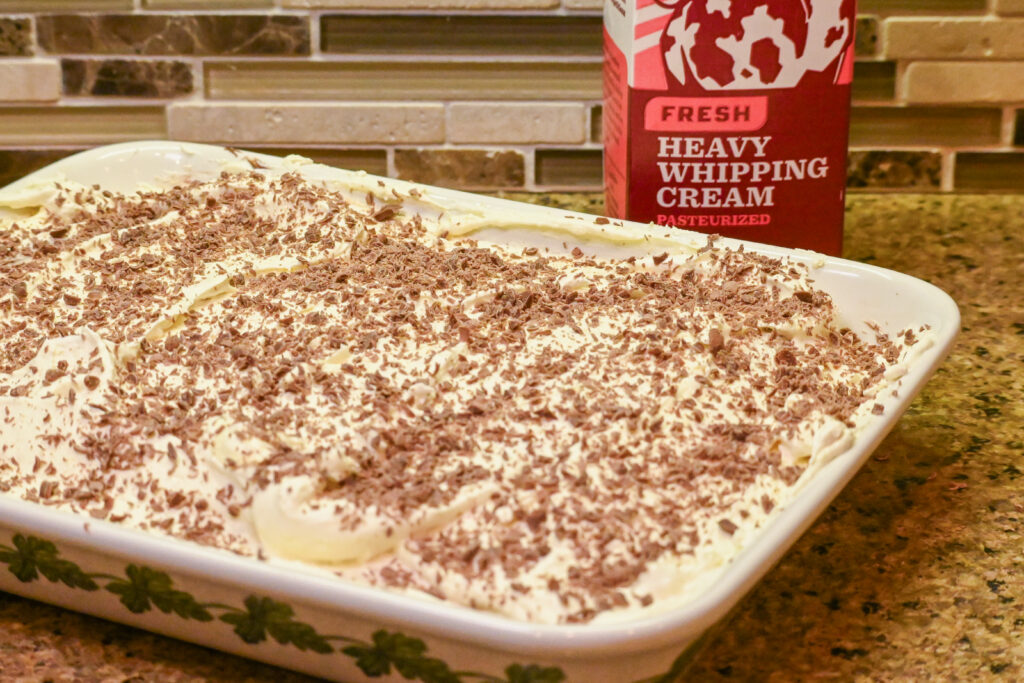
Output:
[{"xmin": 0, "ymin": 533, "xmax": 688, "ymax": 683}]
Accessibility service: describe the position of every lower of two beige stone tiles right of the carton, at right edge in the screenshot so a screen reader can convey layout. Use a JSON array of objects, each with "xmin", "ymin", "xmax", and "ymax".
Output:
[{"xmin": 903, "ymin": 60, "xmax": 1024, "ymax": 103}]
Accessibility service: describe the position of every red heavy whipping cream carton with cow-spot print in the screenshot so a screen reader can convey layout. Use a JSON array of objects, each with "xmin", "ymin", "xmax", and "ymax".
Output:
[{"xmin": 603, "ymin": 0, "xmax": 855, "ymax": 254}]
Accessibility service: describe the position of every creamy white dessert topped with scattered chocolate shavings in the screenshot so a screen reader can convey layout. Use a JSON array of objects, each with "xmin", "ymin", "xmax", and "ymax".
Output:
[{"xmin": 0, "ymin": 154, "xmax": 927, "ymax": 624}]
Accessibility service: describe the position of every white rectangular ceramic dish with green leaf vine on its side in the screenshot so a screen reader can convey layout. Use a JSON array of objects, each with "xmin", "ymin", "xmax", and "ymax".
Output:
[{"xmin": 0, "ymin": 141, "xmax": 959, "ymax": 683}]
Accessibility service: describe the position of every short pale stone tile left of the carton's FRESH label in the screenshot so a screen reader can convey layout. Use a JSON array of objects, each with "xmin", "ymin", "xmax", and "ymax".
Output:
[{"xmin": 449, "ymin": 102, "xmax": 586, "ymax": 144}]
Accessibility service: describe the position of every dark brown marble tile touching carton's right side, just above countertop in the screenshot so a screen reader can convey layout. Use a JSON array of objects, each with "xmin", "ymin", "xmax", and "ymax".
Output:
[{"xmin": 846, "ymin": 150, "xmax": 942, "ymax": 189}]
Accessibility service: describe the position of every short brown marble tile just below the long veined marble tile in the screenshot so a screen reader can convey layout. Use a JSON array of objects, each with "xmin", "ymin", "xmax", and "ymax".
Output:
[{"xmin": 60, "ymin": 59, "xmax": 193, "ymax": 97}]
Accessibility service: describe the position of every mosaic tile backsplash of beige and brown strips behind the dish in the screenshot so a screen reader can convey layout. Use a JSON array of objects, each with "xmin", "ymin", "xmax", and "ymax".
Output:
[{"xmin": 0, "ymin": 0, "xmax": 1024, "ymax": 191}]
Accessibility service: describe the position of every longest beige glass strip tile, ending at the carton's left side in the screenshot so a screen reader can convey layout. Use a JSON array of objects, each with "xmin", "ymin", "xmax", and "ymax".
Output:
[{"xmin": 206, "ymin": 60, "xmax": 601, "ymax": 100}]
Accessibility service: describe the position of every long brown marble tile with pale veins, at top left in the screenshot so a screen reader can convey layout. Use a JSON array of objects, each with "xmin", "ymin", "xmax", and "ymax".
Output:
[{"xmin": 37, "ymin": 14, "xmax": 309, "ymax": 56}]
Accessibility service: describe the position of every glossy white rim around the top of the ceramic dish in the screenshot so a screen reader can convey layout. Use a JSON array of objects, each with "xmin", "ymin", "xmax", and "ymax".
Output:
[{"xmin": 0, "ymin": 140, "xmax": 959, "ymax": 659}]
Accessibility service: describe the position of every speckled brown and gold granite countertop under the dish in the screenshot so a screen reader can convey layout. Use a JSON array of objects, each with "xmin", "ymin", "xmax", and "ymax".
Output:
[{"xmin": 0, "ymin": 195, "xmax": 1024, "ymax": 683}]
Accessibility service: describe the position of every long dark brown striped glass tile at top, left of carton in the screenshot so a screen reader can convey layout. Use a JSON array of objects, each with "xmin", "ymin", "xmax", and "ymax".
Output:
[{"xmin": 321, "ymin": 14, "xmax": 601, "ymax": 56}]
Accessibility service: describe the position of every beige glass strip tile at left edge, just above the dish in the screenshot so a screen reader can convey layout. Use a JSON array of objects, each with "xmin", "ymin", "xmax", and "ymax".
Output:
[{"xmin": 0, "ymin": 106, "xmax": 166, "ymax": 145}]
